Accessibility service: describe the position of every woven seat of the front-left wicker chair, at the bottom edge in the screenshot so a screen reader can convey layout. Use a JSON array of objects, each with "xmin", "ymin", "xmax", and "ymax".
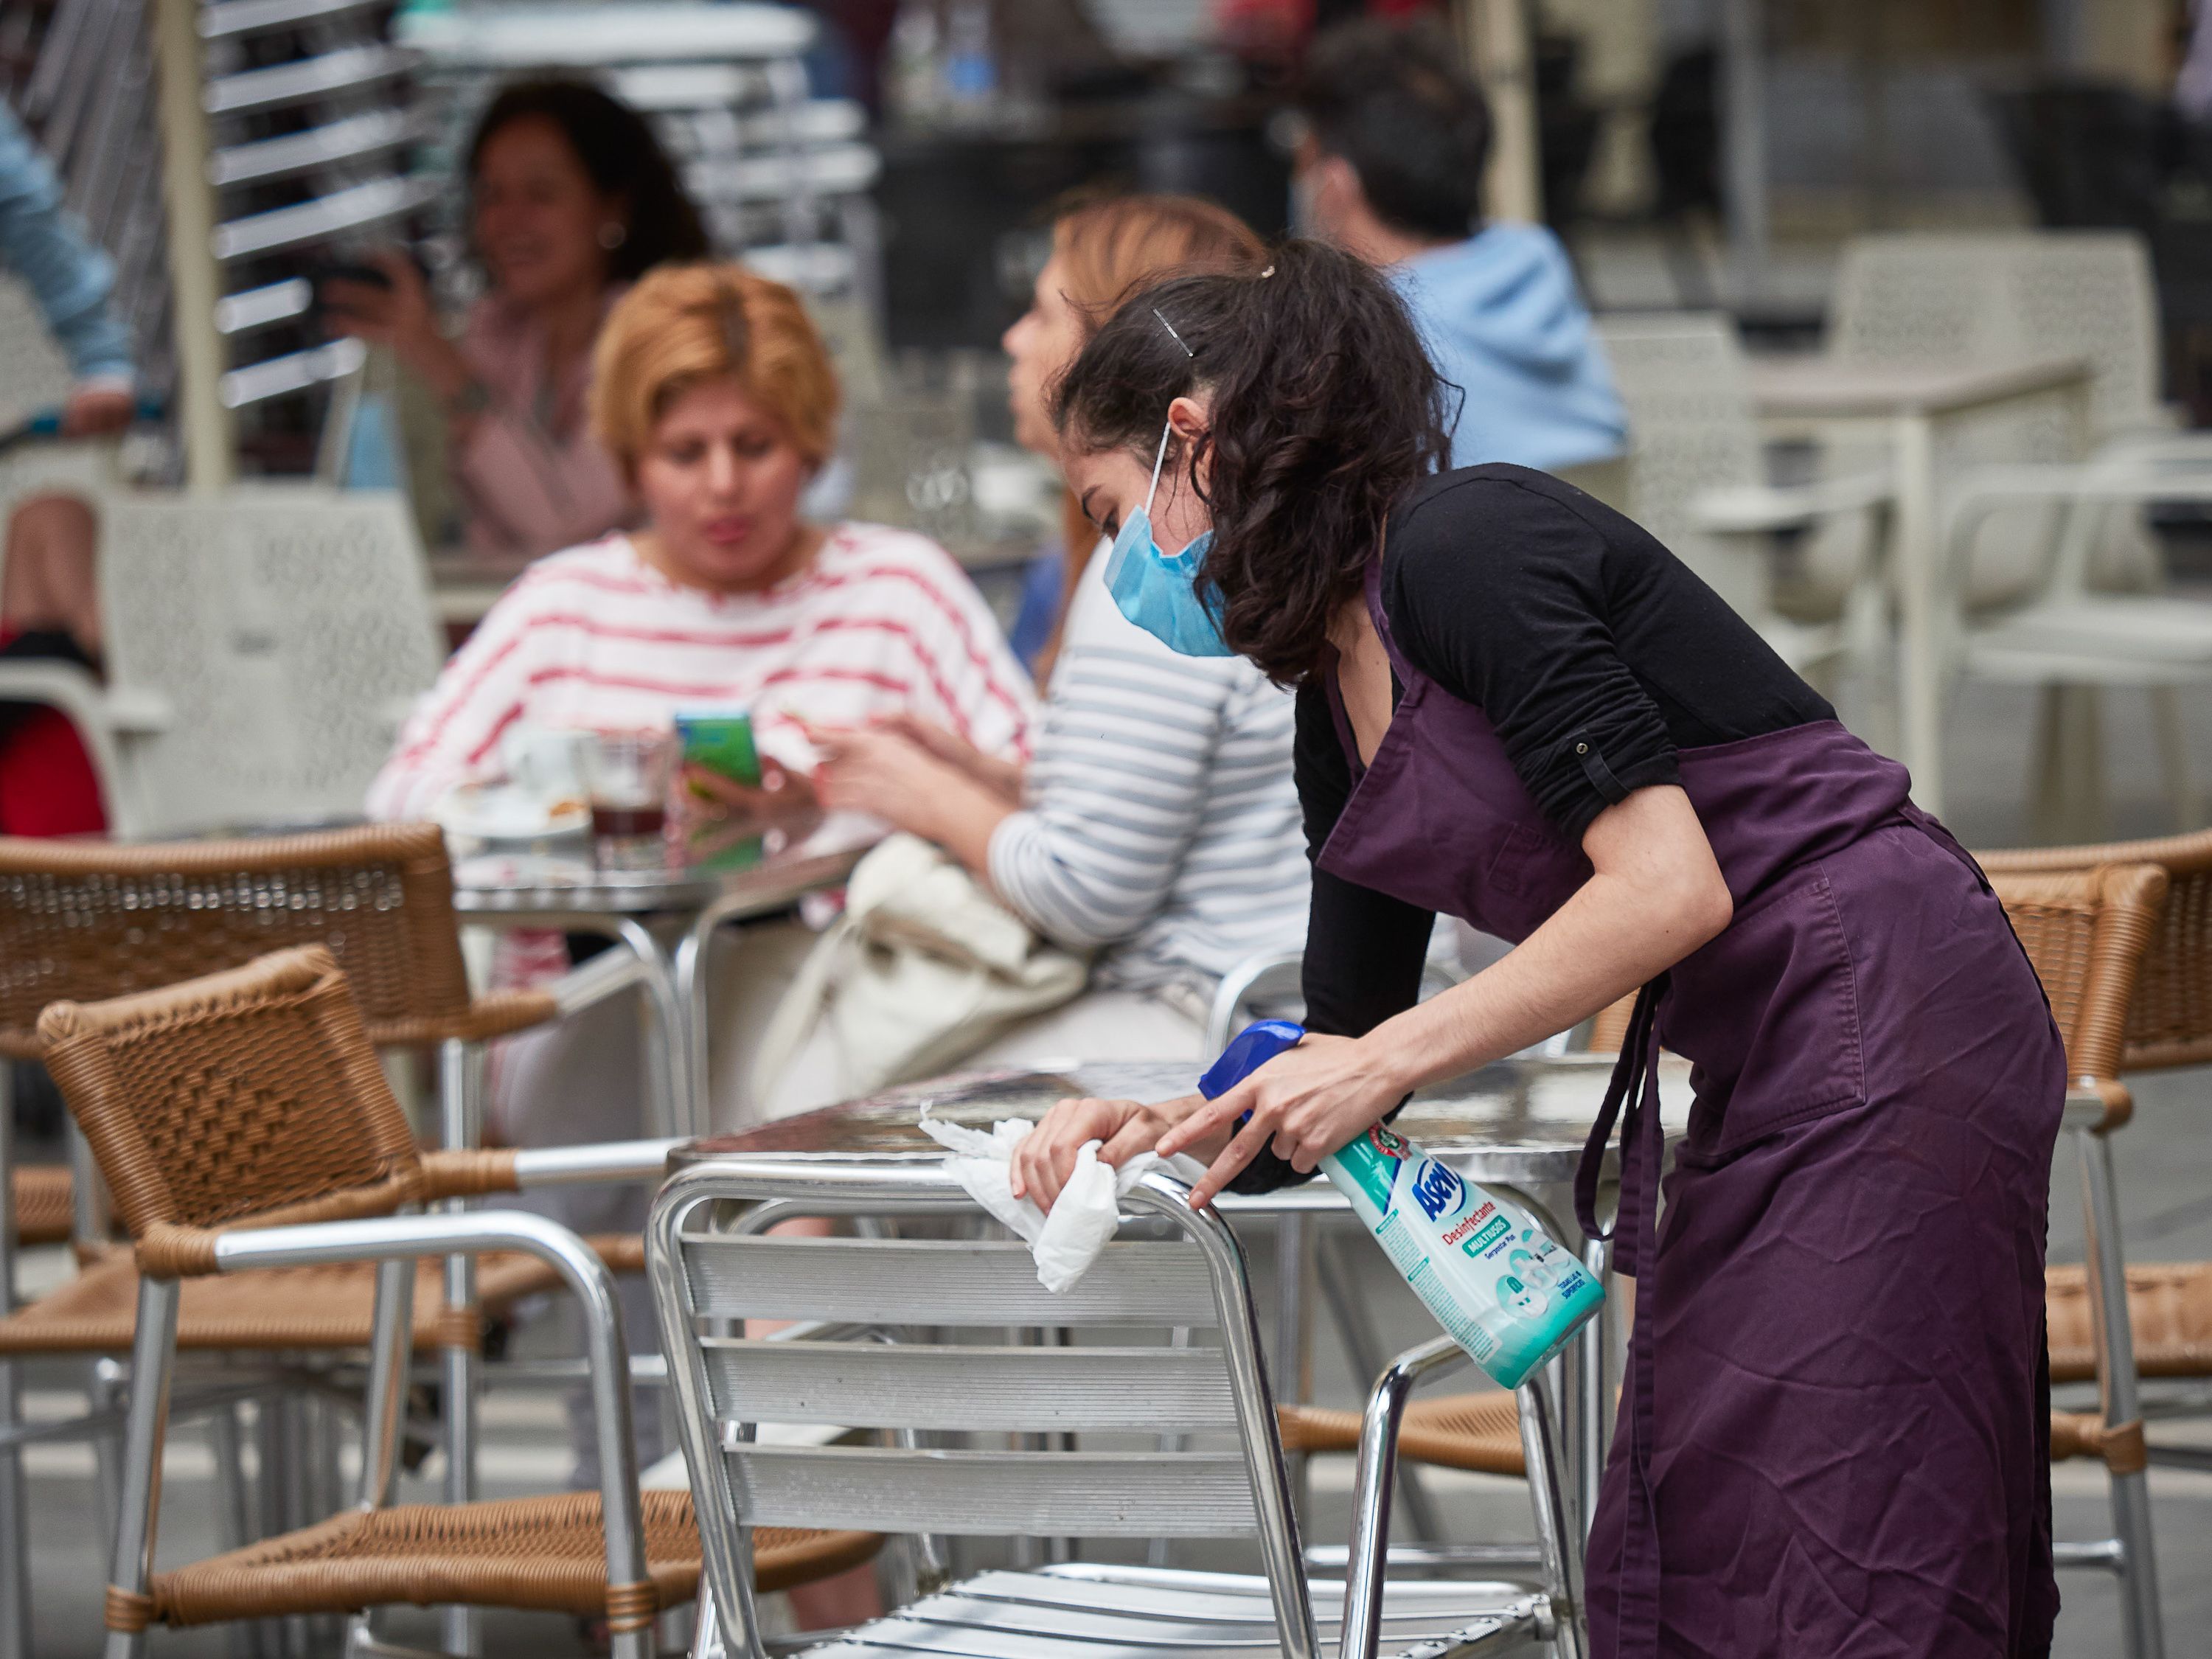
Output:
[{"xmin": 136, "ymin": 1491, "xmax": 883, "ymax": 1626}]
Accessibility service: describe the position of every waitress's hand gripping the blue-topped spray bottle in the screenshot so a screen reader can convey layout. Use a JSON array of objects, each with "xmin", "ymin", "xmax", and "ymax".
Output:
[{"xmin": 1157, "ymin": 1033, "xmax": 1407, "ymax": 1210}]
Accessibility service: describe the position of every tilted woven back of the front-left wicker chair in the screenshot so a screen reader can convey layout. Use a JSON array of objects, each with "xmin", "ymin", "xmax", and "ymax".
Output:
[{"xmin": 38, "ymin": 945, "xmax": 422, "ymax": 1272}]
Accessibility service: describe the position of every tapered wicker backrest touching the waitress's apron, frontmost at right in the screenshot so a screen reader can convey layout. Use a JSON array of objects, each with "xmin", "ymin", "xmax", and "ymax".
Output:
[{"xmin": 1991, "ymin": 863, "xmax": 2166, "ymax": 1104}]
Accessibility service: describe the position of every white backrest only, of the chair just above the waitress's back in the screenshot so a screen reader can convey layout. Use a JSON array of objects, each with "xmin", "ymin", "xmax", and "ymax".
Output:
[{"xmin": 1597, "ymin": 312, "xmax": 1774, "ymax": 624}]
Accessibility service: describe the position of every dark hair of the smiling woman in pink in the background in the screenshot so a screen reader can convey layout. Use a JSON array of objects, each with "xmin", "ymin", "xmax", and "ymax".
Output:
[{"xmin": 467, "ymin": 75, "xmax": 710, "ymax": 283}]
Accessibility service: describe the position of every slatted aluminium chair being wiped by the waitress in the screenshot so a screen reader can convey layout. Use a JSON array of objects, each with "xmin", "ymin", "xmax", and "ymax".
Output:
[{"xmin": 646, "ymin": 1157, "xmax": 1582, "ymax": 1659}]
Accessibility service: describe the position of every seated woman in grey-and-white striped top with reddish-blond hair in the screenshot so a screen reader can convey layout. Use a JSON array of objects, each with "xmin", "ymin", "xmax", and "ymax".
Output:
[{"xmin": 787, "ymin": 195, "xmax": 1307, "ymax": 1110}]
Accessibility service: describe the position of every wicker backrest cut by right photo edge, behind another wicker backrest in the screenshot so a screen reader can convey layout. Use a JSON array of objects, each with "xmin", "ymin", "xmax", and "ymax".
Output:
[{"xmin": 1978, "ymin": 830, "xmax": 2212, "ymax": 1071}]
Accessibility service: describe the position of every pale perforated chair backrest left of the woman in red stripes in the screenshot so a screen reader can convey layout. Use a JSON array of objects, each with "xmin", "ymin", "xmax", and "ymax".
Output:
[{"xmin": 100, "ymin": 484, "xmax": 442, "ymax": 834}]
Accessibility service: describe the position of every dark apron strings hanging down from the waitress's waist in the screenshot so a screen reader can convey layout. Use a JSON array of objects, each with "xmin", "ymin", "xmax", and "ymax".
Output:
[{"xmin": 1575, "ymin": 973, "xmax": 1668, "ymax": 1659}]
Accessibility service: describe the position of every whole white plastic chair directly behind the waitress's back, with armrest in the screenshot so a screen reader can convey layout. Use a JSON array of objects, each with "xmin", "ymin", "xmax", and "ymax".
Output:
[{"xmin": 1597, "ymin": 314, "xmax": 1889, "ymax": 679}]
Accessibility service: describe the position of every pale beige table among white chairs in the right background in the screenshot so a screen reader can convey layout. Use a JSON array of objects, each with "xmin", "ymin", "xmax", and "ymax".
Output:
[{"xmin": 1750, "ymin": 356, "xmax": 2090, "ymax": 814}]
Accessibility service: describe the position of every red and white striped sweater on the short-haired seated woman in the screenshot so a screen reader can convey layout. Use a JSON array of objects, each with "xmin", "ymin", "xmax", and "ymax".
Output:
[{"xmin": 367, "ymin": 524, "xmax": 1035, "ymax": 818}]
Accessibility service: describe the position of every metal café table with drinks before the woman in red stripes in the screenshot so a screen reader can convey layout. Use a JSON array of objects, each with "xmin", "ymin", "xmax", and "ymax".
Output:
[{"xmin": 453, "ymin": 814, "xmax": 883, "ymax": 1135}]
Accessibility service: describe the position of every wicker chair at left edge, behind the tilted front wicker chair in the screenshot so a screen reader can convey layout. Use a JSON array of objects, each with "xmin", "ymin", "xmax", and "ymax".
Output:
[{"xmin": 0, "ymin": 825, "xmax": 668, "ymax": 1659}]
